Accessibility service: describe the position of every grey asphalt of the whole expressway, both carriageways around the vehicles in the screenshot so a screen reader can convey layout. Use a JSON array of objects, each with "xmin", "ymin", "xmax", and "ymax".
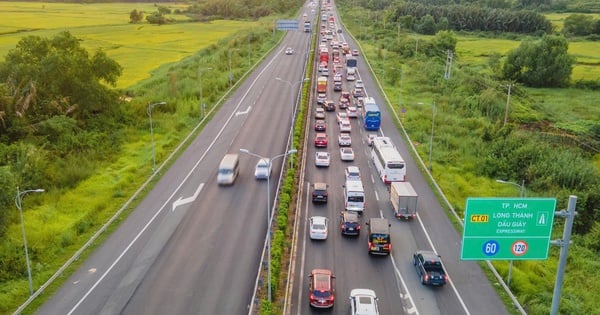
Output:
[{"xmin": 37, "ymin": 1, "xmax": 507, "ymax": 315}]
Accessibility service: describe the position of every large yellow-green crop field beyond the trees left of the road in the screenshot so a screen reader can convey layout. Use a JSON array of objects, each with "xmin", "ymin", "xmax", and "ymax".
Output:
[{"xmin": 0, "ymin": 2, "xmax": 254, "ymax": 88}]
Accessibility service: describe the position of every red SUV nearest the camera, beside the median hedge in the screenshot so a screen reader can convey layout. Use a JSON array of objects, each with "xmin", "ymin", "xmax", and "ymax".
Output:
[{"xmin": 308, "ymin": 269, "xmax": 335, "ymax": 308}]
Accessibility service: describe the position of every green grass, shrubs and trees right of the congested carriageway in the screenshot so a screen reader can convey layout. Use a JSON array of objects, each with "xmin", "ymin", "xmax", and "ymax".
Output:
[{"xmin": 337, "ymin": 0, "xmax": 600, "ymax": 314}]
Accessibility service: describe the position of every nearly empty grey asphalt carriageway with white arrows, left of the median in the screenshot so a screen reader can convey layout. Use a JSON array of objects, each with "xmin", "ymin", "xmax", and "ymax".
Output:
[{"xmin": 37, "ymin": 5, "xmax": 308, "ymax": 314}]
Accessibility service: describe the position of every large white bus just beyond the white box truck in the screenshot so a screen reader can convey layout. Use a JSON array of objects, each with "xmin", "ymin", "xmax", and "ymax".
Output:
[{"xmin": 371, "ymin": 137, "xmax": 406, "ymax": 184}]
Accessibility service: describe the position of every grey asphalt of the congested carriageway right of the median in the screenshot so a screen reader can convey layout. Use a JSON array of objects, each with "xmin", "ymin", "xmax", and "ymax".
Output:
[{"xmin": 286, "ymin": 2, "xmax": 508, "ymax": 315}]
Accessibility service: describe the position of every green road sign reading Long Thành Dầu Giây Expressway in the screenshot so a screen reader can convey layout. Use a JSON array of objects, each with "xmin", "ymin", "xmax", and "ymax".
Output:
[{"xmin": 460, "ymin": 198, "xmax": 556, "ymax": 260}]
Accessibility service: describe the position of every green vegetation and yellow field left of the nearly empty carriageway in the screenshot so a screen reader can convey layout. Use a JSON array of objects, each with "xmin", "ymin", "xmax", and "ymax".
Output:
[{"xmin": 0, "ymin": 1, "xmax": 300, "ymax": 314}]
